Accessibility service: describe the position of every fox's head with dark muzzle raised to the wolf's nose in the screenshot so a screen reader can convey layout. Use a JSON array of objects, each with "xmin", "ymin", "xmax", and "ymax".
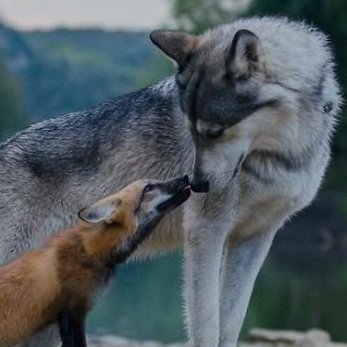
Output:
[{"xmin": 79, "ymin": 176, "xmax": 190, "ymax": 262}]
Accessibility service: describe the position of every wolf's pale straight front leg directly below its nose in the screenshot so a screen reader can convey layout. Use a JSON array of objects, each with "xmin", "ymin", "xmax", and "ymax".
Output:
[{"xmin": 183, "ymin": 193, "xmax": 238, "ymax": 347}]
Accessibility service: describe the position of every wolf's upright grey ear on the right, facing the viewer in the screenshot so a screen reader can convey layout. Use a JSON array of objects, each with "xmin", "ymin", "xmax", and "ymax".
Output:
[{"xmin": 226, "ymin": 29, "xmax": 265, "ymax": 78}]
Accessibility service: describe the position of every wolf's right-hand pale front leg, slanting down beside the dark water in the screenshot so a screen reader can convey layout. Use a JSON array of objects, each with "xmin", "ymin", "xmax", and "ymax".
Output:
[{"xmin": 219, "ymin": 228, "xmax": 277, "ymax": 347}]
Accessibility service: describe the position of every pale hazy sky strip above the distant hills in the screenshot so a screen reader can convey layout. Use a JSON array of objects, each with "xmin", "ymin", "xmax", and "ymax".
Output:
[{"xmin": 0, "ymin": 0, "xmax": 170, "ymax": 29}]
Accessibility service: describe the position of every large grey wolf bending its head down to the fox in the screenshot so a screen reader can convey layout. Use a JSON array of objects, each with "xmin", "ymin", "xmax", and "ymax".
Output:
[{"xmin": 0, "ymin": 17, "xmax": 341, "ymax": 347}]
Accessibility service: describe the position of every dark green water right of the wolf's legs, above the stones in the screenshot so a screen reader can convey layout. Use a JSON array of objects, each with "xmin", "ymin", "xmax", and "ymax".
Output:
[{"xmin": 244, "ymin": 262, "xmax": 347, "ymax": 341}]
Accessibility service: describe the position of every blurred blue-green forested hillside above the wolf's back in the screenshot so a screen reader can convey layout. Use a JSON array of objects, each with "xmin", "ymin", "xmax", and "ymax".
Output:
[{"xmin": 0, "ymin": 24, "xmax": 173, "ymax": 130}]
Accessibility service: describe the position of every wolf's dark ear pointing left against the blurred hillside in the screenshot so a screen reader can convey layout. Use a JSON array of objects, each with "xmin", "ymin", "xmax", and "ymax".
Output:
[{"xmin": 149, "ymin": 30, "xmax": 198, "ymax": 68}]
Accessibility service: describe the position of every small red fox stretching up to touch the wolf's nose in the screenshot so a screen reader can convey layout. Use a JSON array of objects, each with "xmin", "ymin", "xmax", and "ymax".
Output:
[{"xmin": 0, "ymin": 176, "xmax": 190, "ymax": 347}]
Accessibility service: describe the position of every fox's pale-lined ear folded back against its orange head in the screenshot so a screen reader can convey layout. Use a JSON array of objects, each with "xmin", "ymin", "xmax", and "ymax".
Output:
[{"xmin": 78, "ymin": 200, "xmax": 120, "ymax": 223}]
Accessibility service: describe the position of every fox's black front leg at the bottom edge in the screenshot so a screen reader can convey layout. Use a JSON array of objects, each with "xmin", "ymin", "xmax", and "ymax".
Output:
[{"xmin": 58, "ymin": 311, "xmax": 87, "ymax": 347}]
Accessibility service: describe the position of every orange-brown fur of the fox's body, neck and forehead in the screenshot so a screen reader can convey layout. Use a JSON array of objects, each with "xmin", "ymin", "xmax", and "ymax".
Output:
[{"xmin": 0, "ymin": 181, "xmax": 145, "ymax": 347}]
